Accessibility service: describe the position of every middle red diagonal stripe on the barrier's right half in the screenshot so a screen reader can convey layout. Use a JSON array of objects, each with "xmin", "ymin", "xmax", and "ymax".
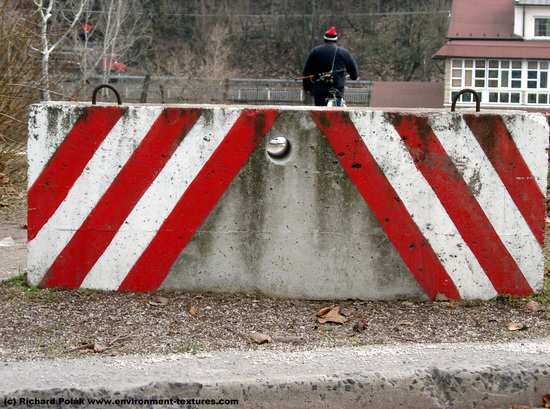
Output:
[{"xmin": 390, "ymin": 114, "xmax": 533, "ymax": 295}]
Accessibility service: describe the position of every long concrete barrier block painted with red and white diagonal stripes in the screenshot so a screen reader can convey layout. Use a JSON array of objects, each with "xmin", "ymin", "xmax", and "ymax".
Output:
[{"xmin": 28, "ymin": 103, "xmax": 549, "ymax": 300}]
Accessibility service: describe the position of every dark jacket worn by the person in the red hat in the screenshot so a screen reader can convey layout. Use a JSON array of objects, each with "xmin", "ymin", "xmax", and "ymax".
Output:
[{"xmin": 302, "ymin": 42, "xmax": 359, "ymax": 97}]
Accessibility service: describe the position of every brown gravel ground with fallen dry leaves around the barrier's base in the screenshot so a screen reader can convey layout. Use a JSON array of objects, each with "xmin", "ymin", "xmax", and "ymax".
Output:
[{"xmin": 0, "ymin": 163, "xmax": 550, "ymax": 361}]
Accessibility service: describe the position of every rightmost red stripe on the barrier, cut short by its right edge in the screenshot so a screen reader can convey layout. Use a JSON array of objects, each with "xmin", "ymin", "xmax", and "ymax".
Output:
[{"xmin": 464, "ymin": 114, "xmax": 546, "ymax": 246}]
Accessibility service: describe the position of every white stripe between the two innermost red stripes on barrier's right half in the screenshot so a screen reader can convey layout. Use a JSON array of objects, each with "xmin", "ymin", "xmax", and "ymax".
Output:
[{"xmin": 350, "ymin": 112, "xmax": 497, "ymax": 299}]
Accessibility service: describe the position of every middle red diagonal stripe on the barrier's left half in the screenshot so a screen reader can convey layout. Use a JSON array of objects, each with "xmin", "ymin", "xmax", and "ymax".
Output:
[{"xmin": 40, "ymin": 108, "xmax": 201, "ymax": 288}]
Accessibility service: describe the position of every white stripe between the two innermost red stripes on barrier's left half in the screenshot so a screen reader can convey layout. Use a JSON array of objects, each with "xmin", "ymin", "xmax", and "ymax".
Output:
[{"xmin": 81, "ymin": 108, "xmax": 241, "ymax": 289}]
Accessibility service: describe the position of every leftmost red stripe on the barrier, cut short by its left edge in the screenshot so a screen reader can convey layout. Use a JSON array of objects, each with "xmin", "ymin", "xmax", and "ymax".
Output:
[{"xmin": 27, "ymin": 107, "xmax": 123, "ymax": 241}]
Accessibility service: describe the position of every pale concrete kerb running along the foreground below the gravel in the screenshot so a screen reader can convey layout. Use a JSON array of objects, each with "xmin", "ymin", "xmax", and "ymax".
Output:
[{"xmin": 0, "ymin": 339, "xmax": 550, "ymax": 409}]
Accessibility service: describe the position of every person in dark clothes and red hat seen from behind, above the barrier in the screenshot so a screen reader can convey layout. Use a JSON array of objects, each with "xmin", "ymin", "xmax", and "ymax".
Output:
[{"xmin": 302, "ymin": 27, "xmax": 359, "ymax": 106}]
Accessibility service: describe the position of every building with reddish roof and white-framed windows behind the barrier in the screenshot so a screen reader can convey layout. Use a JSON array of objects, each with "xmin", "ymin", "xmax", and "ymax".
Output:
[{"xmin": 433, "ymin": 0, "xmax": 550, "ymax": 111}]
